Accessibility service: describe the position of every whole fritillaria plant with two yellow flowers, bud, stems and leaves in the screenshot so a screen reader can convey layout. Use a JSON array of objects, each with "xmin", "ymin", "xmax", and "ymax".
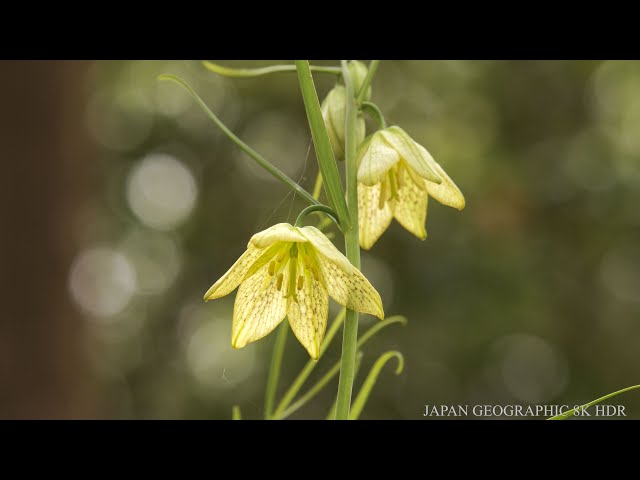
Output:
[{"xmin": 160, "ymin": 60, "xmax": 465, "ymax": 419}]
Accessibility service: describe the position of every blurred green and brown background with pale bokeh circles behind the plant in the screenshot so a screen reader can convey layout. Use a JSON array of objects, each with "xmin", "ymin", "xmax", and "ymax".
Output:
[{"xmin": 0, "ymin": 61, "xmax": 640, "ymax": 419}]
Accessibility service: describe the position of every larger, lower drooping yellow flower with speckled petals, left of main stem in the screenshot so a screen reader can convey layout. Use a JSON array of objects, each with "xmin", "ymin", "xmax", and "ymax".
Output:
[{"xmin": 204, "ymin": 223, "xmax": 384, "ymax": 359}]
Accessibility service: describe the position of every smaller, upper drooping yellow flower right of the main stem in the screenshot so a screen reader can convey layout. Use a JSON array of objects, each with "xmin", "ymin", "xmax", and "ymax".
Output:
[{"xmin": 358, "ymin": 126, "xmax": 465, "ymax": 250}]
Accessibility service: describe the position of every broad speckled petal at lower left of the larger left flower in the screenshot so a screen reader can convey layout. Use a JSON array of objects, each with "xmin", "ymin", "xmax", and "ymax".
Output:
[{"xmin": 231, "ymin": 258, "xmax": 288, "ymax": 348}]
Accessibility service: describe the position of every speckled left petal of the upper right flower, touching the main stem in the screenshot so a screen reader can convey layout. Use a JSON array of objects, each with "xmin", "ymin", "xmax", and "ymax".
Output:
[{"xmin": 358, "ymin": 183, "xmax": 393, "ymax": 250}]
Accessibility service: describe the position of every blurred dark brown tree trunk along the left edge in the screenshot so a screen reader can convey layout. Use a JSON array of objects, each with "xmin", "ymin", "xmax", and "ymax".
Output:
[{"xmin": 0, "ymin": 61, "xmax": 94, "ymax": 418}]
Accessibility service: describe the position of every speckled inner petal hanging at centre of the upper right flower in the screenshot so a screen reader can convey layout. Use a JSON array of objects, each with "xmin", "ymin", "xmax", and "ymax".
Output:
[{"xmin": 393, "ymin": 165, "xmax": 429, "ymax": 240}]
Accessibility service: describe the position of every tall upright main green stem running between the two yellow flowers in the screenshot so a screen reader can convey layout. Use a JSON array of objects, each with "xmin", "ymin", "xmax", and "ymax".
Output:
[{"xmin": 336, "ymin": 60, "xmax": 360, "ymax": 420}]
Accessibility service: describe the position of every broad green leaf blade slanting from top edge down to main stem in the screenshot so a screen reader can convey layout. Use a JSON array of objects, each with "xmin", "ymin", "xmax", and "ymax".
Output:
[{"xmin": 296, "ymin": 60, "xmax": 350, "ymax": 229}]
